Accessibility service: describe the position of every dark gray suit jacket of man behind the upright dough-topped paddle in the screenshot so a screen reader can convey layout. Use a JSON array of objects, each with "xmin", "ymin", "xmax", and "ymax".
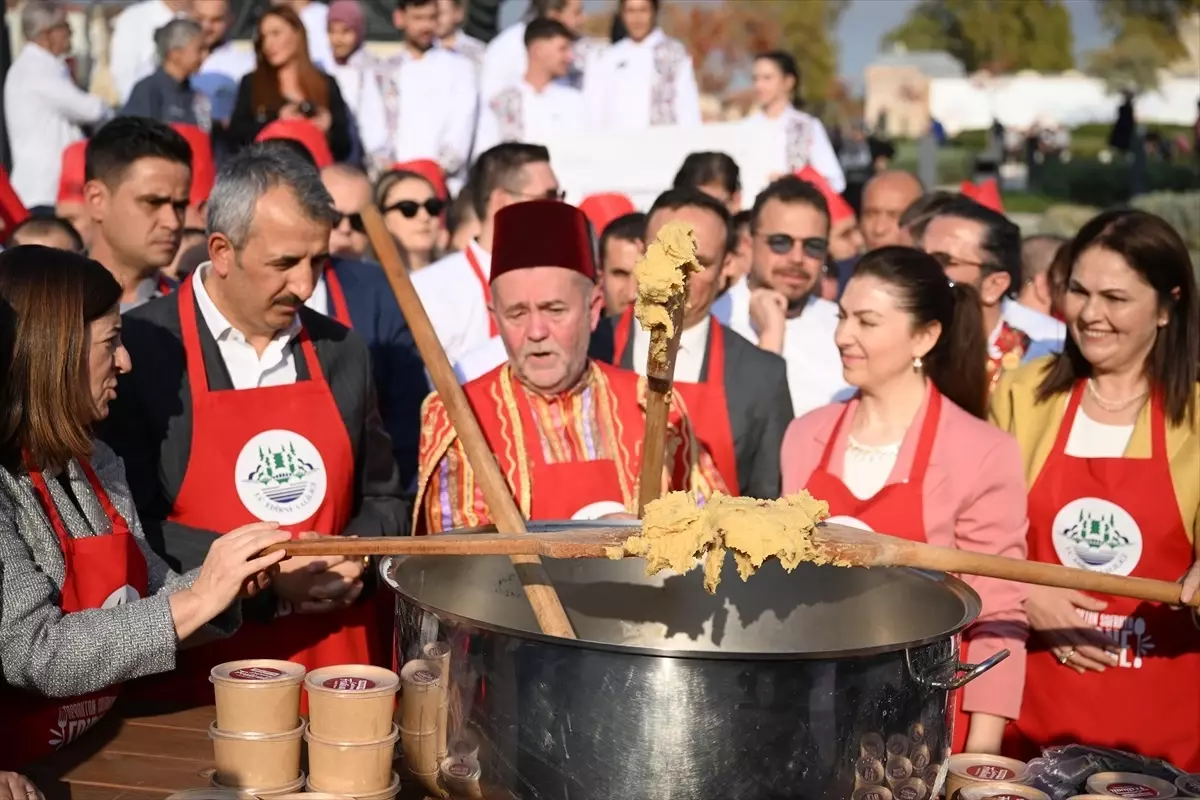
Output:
[{"xmin": 588, "ymin": 317, "xmax": 793, "ymax": 500}]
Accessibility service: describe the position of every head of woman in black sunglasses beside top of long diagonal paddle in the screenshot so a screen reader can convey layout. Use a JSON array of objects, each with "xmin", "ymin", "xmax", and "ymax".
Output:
[{"xmin": 374, "ymin": 169, "xmax": 446, "ymax": 271}]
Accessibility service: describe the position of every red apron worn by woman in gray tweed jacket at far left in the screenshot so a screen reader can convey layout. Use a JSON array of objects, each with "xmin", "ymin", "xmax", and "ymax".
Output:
[{"xmin": 0, "ymin": 462, "xmax": 149, "ymax": 769}]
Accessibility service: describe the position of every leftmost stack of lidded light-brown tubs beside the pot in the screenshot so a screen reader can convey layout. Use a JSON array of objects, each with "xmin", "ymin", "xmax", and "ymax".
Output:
[{"xmin": 209, "ymin": 658, "xmax": 305, "ymax": 796}]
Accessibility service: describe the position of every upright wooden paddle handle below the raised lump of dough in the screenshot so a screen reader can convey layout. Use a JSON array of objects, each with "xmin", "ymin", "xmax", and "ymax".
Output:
[{"xmin": 635, "ymin": 292, "xmax": 688, "ymax": 517}]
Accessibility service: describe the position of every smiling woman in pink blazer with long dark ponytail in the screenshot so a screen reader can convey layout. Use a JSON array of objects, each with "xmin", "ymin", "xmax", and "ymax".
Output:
[{"xmin": 781, "ymin": 247, "xmax": 1027, "ymax": 753}]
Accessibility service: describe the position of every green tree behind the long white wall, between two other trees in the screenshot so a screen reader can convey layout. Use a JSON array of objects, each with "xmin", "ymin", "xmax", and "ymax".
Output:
[{"xmin": 883, "ymin": 0, "xmax": 1074, "ymax": 72}]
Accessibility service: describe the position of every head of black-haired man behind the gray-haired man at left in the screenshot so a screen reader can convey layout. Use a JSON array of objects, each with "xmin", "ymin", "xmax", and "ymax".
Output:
[{"xmin": 84, "ymin": 116, "xmax": 192, "ymax": 312}]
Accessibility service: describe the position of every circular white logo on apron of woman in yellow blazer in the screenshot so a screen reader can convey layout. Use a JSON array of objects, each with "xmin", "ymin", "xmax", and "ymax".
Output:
[{"xmin": 1051, "ymin": 498, "xmax": 1141, "ymax": 576}]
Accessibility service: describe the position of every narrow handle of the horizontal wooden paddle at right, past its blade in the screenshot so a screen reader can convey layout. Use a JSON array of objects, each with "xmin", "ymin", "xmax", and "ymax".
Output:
[{"xmin": 893, "ymin": 542, "xmax": 1200, "ymax": 608}]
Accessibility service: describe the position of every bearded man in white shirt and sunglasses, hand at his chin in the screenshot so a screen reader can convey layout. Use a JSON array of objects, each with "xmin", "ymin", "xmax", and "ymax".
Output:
[{"xmin": 728, "ymin": 175, "xmax": 852, "ymax": 416}]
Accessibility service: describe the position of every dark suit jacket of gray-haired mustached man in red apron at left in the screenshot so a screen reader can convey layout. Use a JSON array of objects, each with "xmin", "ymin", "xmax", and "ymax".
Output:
[{"xmin": 97, "ymin": 294, "xmax": 410, "ymax": 582}]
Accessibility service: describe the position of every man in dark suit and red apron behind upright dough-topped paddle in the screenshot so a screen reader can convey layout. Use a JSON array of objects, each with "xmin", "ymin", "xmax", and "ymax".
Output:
[{"xmin": 589, "ymin": 190, "xmax": 792, "ymax": 498}]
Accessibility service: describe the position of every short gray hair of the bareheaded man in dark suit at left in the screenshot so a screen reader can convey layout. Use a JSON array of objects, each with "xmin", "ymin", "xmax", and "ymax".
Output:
[{"xmin": 208, "ymin": 142, "xmax": 337, "ymax": 251}]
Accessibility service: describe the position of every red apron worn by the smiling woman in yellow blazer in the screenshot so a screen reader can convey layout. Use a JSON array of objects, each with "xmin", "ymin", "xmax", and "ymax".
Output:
[{"xmin": 1006, "ymin": 381, "xmax": 1200, "ymax": 772}]
